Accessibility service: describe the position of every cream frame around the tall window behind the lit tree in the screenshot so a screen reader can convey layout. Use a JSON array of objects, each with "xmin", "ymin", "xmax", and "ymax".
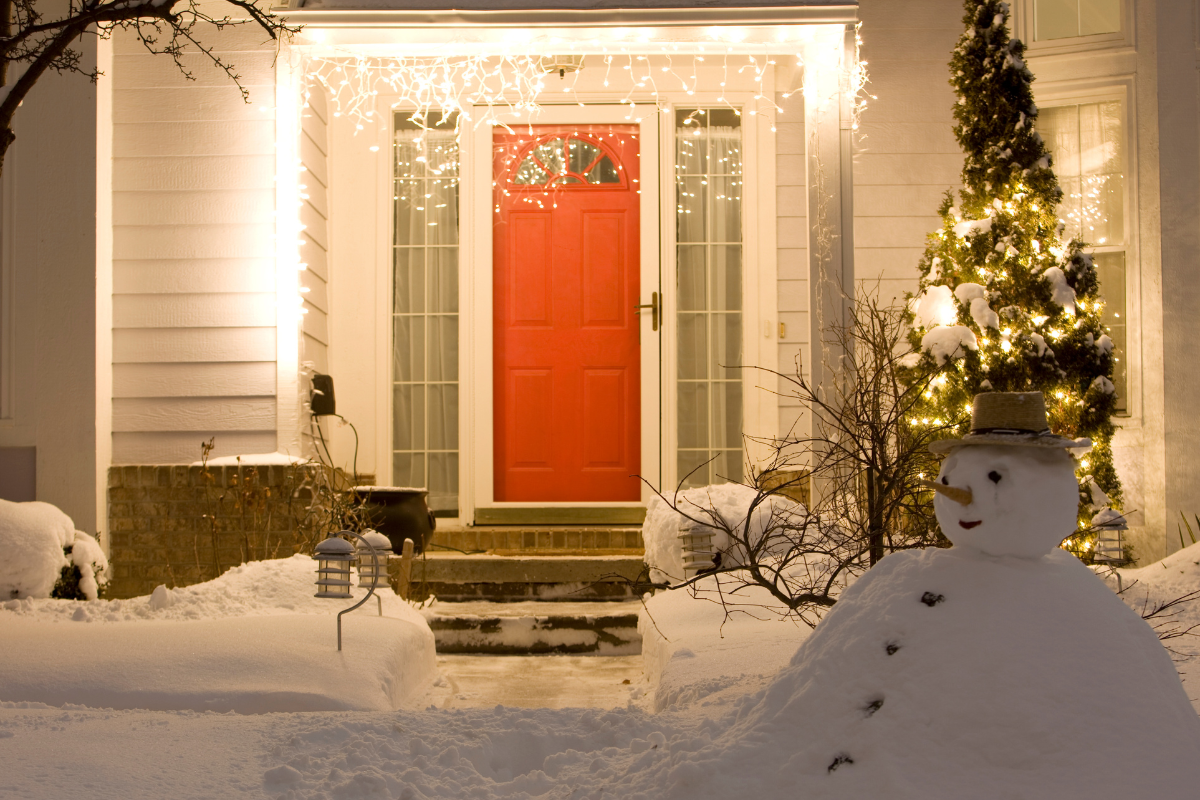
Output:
[{"xmin": 1034, "ymin": 77, "xmax": 1144, "ymax": 427}]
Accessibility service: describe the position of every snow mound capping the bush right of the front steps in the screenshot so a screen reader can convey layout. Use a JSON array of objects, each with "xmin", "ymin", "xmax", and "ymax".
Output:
[{"xmin": 642, "ymin": 483, "xmax": 803, "ymax": 583}]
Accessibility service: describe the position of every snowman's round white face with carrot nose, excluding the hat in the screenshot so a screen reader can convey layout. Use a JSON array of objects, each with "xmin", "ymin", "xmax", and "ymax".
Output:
[{"xmin": 934, "ymin": 445, "xmax": 1079, "ymax": 558}]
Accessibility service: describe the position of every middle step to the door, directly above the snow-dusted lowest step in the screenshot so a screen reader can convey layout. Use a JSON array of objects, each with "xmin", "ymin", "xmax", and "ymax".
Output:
[{"xmin": 389, "ymin": 552, "xmax": 652, "ymax": 602}]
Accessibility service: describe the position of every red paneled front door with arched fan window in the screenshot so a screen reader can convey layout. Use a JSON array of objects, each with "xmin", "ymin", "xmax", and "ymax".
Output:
[{"xmin": 492, "ymin": 125, "xmax": 641, "ymax": 503}]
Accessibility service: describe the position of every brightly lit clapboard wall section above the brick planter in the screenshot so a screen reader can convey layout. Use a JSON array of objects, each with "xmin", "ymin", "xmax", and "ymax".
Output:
[{"xmin": 112, "ymin": 26, "xmax": 276, "ymax": 464}]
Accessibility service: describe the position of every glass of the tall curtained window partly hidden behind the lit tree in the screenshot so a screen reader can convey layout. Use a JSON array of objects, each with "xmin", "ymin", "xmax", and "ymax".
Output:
[{"xmin": 1037, "ymin": 100, "xmax": 1129, "ymax": 413}]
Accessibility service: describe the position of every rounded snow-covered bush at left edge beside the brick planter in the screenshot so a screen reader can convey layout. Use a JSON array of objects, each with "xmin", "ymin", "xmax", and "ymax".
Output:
[{"xmin": 0, "ymin": 500, "xmax": 108, "ymax": 600}]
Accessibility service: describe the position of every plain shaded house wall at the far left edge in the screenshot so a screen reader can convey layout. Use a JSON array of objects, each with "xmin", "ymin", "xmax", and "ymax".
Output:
[{"xmin": 0, "ymin": 32, "xmax": 107, "ymax": 533}]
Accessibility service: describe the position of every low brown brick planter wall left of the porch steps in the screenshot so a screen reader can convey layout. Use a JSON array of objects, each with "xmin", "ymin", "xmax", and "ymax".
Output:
[{"xmin": 107, "ymin": 464, "xmax": 348, "ymax": 597}]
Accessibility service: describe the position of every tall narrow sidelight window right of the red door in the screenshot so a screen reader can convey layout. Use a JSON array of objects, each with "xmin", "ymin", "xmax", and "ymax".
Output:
[{"xmin": 674, "ymin": 109, "xmax": 743, "ymax": 486}]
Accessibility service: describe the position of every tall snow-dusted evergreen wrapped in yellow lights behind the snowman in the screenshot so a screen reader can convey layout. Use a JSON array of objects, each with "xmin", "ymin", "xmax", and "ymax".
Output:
[{"xmin": 910, "ymin": 0, "xmax": 1121, "ymax": 559}]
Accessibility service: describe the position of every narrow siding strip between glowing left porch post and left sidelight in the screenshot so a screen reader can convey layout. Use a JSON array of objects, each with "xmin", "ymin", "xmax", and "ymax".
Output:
[{"xmin": 300, "ymin": 86, "xmax": 329, "ymax": 372}]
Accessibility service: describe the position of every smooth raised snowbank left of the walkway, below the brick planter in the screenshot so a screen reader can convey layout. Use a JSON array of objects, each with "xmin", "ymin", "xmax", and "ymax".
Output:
[{"xmin": 0, "ymin": 555, "xmax": 437, "ymax": 714}]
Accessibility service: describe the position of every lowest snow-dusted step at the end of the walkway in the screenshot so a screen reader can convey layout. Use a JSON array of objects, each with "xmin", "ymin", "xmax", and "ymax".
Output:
[{"xmin": 421, "ymin": 601, "xmax": 642, "ymax": 656}]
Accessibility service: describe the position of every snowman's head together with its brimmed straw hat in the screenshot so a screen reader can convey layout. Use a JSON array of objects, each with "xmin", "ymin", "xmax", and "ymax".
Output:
[{"xmin": 930, "ymin": 392, "xmax": 1092, "ymax": 558}]
